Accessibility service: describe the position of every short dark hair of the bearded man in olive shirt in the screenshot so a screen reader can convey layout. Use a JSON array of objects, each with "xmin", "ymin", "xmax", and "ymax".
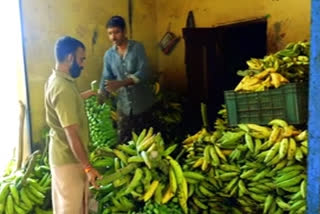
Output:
[{"xmin": 54, "ymin": 36, "xmax": 85, "ymax": 62}]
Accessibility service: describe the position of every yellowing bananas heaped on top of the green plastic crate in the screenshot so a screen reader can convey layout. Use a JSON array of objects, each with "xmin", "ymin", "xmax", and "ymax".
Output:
[{"xmin": 234, "ymin": 42, "xmax": 310, "ymax": 92}]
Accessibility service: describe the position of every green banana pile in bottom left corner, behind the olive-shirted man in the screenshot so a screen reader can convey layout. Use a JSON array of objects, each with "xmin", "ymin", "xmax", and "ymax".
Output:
[{"xmin": 0, "ymin": 151, "xmax": 52, "ymax": 214}]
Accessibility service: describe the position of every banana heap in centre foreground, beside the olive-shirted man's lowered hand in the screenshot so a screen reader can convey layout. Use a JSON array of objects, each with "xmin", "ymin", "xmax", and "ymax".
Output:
[{"xmin": 92, "ymin": 127, "xmax": 188, "ymax": 214}]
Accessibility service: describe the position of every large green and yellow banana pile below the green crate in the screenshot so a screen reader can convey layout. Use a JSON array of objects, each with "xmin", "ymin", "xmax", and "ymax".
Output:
[{"xmin": 183, "ymin": 119, "xmax": 308, "ymax": 214}]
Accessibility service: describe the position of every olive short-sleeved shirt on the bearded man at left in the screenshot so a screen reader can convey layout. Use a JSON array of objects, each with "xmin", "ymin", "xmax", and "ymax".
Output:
[{"xmin": 45, "ymin": 70, "xmax": 89, "ymax": 166}]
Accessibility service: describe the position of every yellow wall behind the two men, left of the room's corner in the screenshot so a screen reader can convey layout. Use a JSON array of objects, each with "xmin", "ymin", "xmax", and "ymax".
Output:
[{"xmin": 21, "ymin": 0, "xmax": 157, "ymax": 142}]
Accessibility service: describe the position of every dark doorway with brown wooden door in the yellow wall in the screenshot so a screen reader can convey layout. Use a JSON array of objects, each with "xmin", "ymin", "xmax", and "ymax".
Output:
[{"xmin": 183, "ymin": 19, "xmax": 267, "ymax": 131}]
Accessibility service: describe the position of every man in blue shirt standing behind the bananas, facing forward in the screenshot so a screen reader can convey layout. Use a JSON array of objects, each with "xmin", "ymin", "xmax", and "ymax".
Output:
[{"xmin": 100, "ymin": 16, "xmax": 154, "ymax": 142}]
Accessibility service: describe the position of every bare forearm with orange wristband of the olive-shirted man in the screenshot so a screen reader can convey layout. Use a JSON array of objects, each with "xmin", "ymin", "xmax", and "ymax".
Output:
[{"xmin": 64, "ymin": 124, "xmax": 101, "ymax": 188}]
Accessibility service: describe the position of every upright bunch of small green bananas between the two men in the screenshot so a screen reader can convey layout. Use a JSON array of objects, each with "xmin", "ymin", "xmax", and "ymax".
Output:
[{"xmin": 85, "ymin": 96, "xmax": 117, "ymax": 151}]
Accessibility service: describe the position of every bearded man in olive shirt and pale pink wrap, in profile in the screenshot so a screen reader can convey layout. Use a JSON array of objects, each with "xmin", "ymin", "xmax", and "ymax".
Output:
[{"xmin": 45, "ymin": 36, "xmax": 100, "ymax": 214}]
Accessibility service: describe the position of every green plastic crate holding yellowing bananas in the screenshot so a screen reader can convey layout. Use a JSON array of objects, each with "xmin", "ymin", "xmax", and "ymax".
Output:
[{"xmin": 224, "ymin": 83, "xmax": 308, "ymax": 126}]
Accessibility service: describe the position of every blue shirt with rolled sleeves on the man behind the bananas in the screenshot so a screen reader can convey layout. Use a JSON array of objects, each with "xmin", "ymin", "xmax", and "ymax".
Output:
[{"xmin": 100, "ymin": 40, "xmax": 154, "ymax": 115}]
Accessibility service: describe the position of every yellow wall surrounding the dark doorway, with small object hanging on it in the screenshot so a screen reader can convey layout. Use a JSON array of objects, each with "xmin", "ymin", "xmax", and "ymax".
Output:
[{"xmin": 156, "ymin": 0, "xmax": 310, "ymax": 91}]
